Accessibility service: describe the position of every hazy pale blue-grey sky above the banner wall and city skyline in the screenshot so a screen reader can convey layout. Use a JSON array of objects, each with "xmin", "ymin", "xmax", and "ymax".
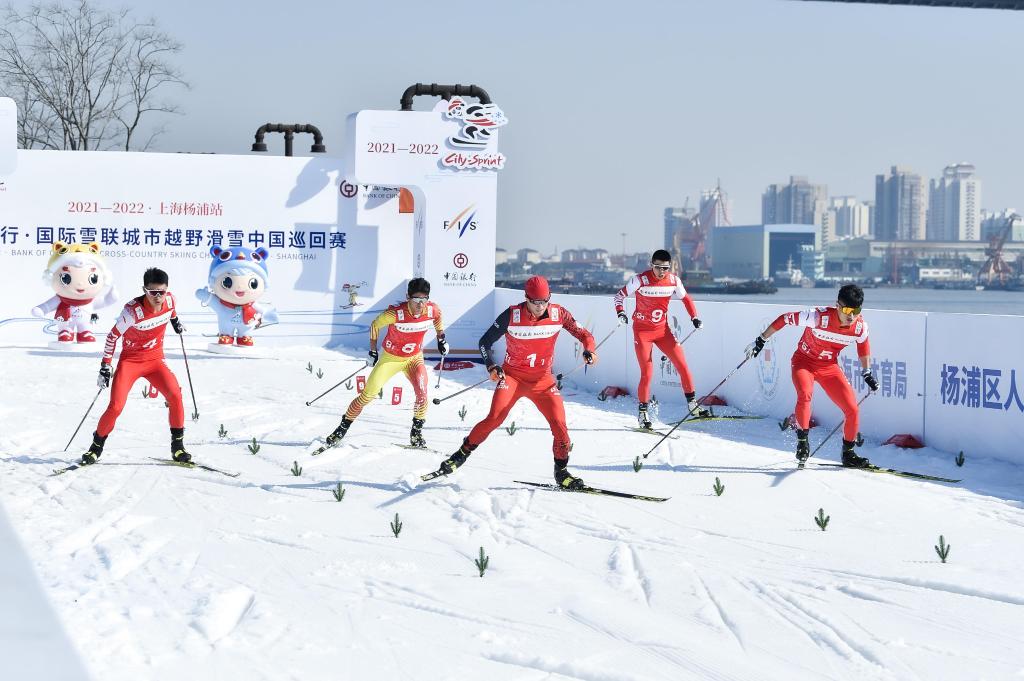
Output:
[{"xmin": 28, "ymin": 0, "xmax": 1024, "ymax": 252}]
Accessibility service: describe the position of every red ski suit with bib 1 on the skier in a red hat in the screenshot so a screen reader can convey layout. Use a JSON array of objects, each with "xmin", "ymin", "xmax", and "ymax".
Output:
[{"xmin": 466, "ymin": 302, "xmax": 594, "ymax": 461}]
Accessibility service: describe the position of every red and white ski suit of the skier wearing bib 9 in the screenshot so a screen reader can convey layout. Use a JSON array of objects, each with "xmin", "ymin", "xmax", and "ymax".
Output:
[{"xmin": 615, "ymin": 269, "xmax": 697, "ymax": 402}]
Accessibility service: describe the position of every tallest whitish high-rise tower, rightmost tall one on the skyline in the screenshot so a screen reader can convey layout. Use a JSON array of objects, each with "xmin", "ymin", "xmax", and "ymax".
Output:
[{"xmin": 926, "ymin": 163, "xmax": 982, "ymax": 242}]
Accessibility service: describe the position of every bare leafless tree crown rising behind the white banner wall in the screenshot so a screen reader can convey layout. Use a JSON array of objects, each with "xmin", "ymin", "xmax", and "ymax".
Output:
[{"xmin": 0, "ymin": 0, "xmax": 188, "ymax": 151}]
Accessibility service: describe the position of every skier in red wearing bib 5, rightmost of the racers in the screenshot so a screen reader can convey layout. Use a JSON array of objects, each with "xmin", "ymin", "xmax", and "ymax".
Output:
[{"xmin": 746, "ymin": 284, "xmax": 879, "ymax": 468}]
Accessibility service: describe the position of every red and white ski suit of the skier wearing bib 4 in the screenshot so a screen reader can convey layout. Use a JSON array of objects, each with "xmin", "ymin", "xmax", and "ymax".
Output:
[{"xmin": 96, "ymin": 293, "xmax": 185, "ymax": 437}]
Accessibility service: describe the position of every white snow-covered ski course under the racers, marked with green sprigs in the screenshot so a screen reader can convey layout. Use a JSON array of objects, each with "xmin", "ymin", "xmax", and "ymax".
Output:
[{"xmin": 0, "ymin": 346, "xmax": 1024, "ymax": 681}]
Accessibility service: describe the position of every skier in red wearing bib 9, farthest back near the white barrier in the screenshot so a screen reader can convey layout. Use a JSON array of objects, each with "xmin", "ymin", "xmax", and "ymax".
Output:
[{"xmin": 614, "ymin": 249, "xmax": 711, "ymax": 430}]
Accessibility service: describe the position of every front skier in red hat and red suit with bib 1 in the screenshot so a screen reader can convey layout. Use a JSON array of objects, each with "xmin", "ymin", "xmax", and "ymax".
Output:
[{"xmin": 439, "ymin": 276, "xmax": 597, "ymax": 490}]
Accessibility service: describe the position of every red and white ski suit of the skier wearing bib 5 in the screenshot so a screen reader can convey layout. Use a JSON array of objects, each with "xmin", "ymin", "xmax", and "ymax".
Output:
[{"xmin": 771, "ymin": 307, "xmax": 871, "ymax": 441}]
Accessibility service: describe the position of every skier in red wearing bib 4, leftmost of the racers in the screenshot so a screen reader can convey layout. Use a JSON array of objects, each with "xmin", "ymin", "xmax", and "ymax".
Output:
[{"xmin": 82, "ymin": 267, "xmax": 191, "ymax": 465}]
